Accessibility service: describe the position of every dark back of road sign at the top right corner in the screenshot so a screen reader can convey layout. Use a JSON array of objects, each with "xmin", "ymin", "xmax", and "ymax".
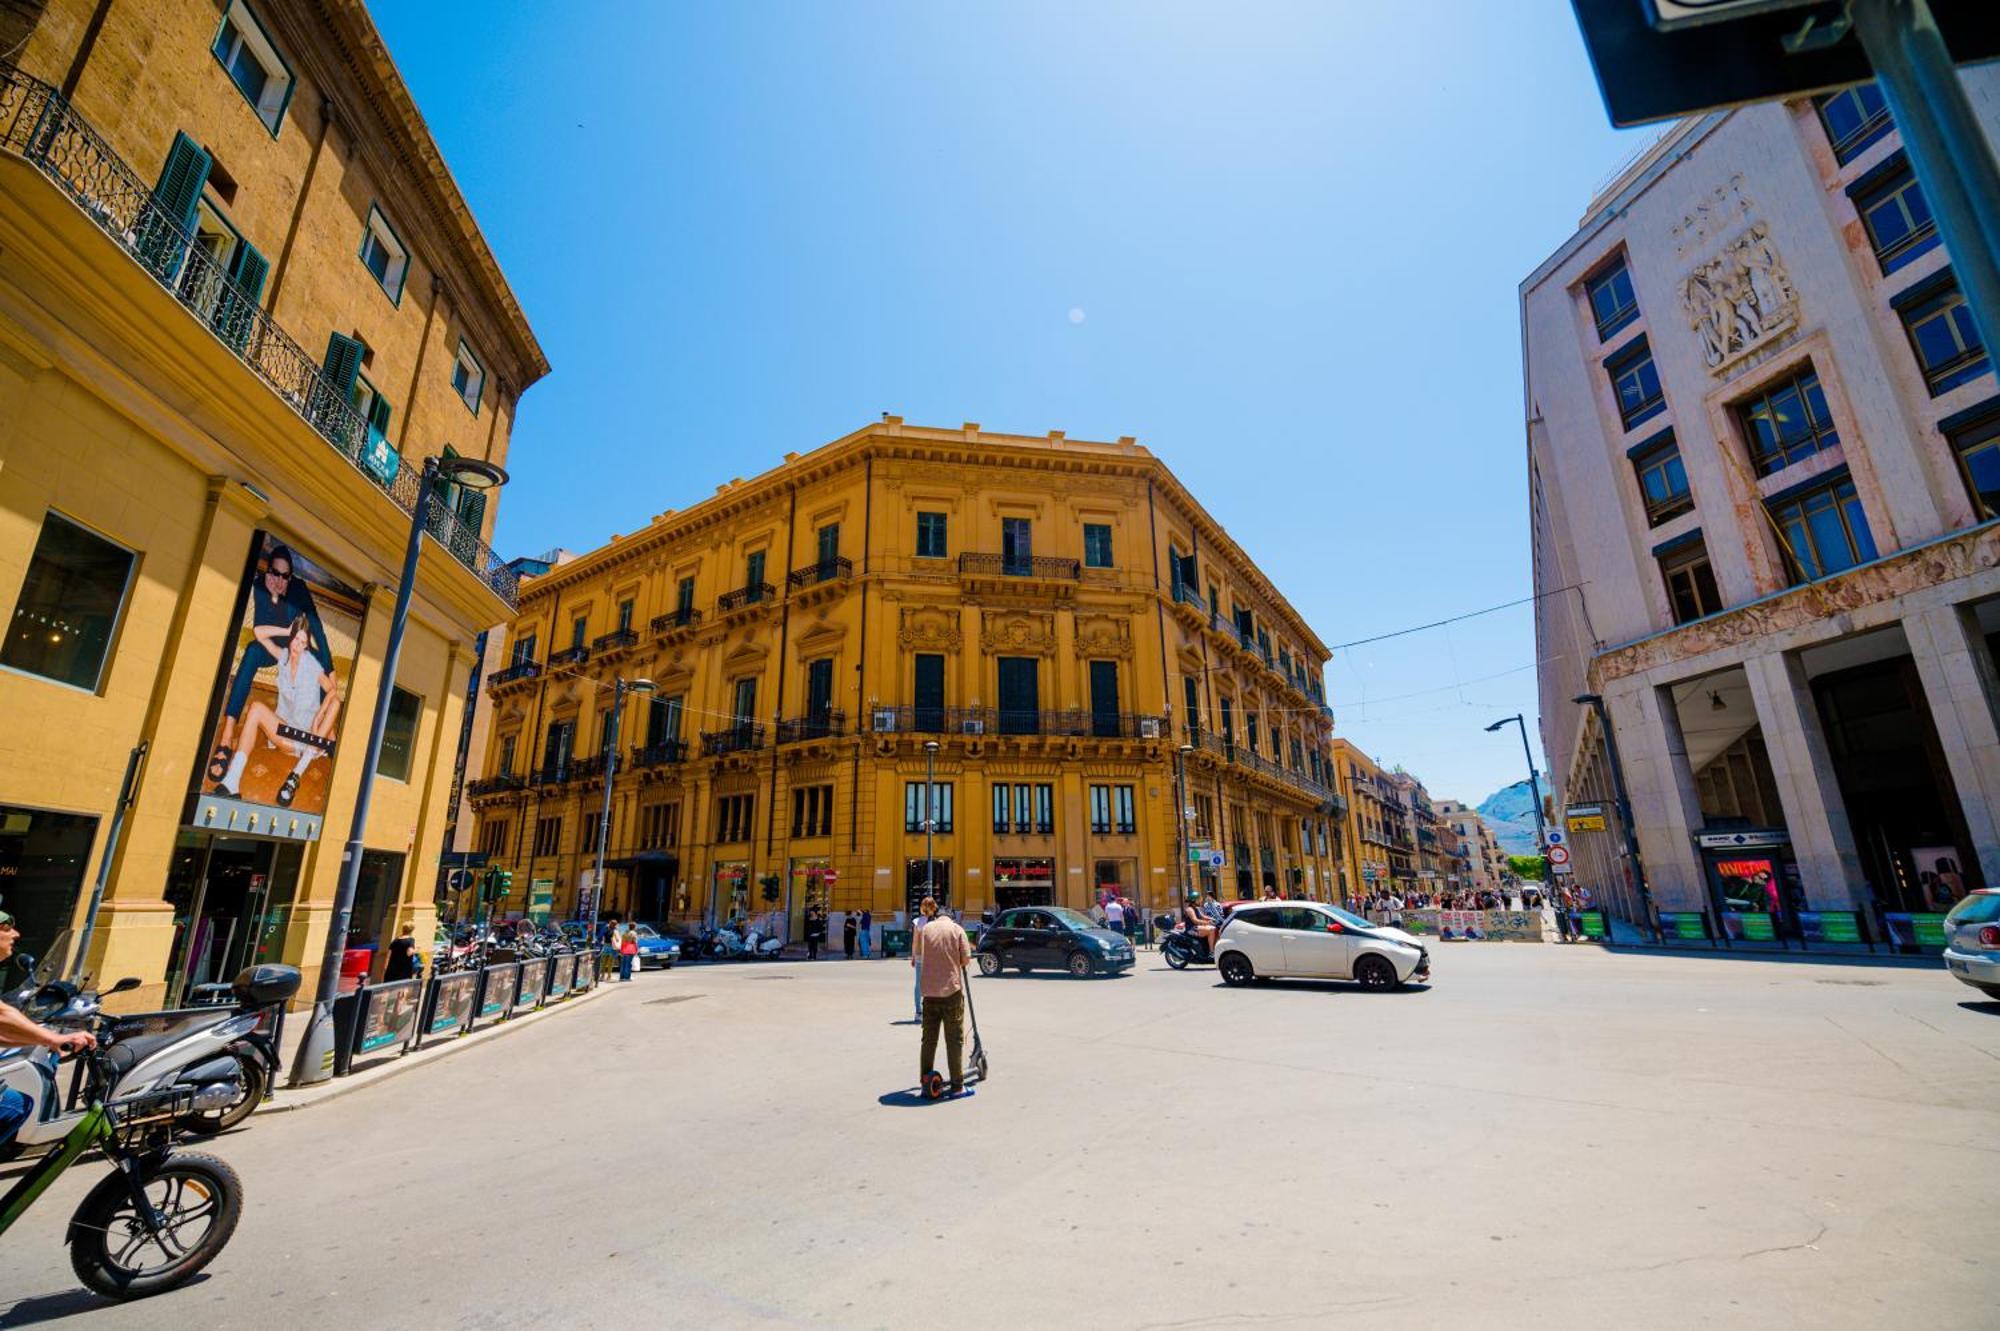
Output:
[{"xmin": 1572, "ymin": 0, "xmax": 2000, "ymax": 126}]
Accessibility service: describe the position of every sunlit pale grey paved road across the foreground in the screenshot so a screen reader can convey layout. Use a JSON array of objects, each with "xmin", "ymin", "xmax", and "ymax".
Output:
[{"xmin": 0, "ymin": 943, "xmax": 2000, "ymax": 1331}]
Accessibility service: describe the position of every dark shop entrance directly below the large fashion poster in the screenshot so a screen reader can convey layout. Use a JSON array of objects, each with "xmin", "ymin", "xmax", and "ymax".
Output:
[{"xmin": 166, "ymin": 831, "xmax": 300, "ymax": 1007}]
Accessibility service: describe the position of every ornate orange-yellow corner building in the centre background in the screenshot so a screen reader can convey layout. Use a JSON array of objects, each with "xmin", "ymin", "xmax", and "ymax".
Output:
[{"xmin": 470, "ymin": 418, "xmax": 1340, "ymax": 939}]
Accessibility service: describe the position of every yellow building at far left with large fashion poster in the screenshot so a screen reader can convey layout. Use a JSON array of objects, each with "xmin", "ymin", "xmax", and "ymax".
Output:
[{"xmin": 0, "ymin": 0, "xmax": 548, "ymax": 1007}]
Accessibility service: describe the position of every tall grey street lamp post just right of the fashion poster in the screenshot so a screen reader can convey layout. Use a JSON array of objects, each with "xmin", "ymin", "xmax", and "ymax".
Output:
[{"xmin": 292, "ymin": 458, "xmax": 506, "ymax": 1085}]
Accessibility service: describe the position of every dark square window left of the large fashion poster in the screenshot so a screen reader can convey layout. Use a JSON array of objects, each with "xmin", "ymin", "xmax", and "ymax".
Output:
[{"xmin": 0, "ymin": 514, "xmax": 138, "ymax": 693}]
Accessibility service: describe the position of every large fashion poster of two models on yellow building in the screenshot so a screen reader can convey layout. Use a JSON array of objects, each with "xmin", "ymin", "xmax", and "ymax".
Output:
[{"xmin": 188, "ymin": 532, "xmax": 364, "ymax": 841}]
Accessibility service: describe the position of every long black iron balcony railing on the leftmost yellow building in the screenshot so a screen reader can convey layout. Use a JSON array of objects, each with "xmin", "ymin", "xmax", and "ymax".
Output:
[{"xmin": 0, "ymin": 66, "xmax": 520, "ymax": 610}]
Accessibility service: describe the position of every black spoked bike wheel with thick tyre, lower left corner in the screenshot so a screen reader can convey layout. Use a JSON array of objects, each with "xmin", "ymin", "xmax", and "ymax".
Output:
[{"xmin": 70, "ymin": 1153, "xmax": 244, "ymax": 1299}]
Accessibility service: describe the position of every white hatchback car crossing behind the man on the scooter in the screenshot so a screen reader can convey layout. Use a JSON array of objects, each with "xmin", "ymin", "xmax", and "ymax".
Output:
[{"xmin": 1216, "ymin": 901, "xmax": 1430, "ymax": 989}]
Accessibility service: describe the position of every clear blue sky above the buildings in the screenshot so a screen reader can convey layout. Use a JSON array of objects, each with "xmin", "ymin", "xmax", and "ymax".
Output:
[{"xmin": 374, "ymin": 0, "xmax": 1650, "ymax": 801}]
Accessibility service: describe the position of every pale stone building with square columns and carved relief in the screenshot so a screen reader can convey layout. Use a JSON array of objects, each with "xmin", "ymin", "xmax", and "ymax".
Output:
[{"xmin": 1520, "ymin": 77, "xmax": 2000, "ymax": 941}]
